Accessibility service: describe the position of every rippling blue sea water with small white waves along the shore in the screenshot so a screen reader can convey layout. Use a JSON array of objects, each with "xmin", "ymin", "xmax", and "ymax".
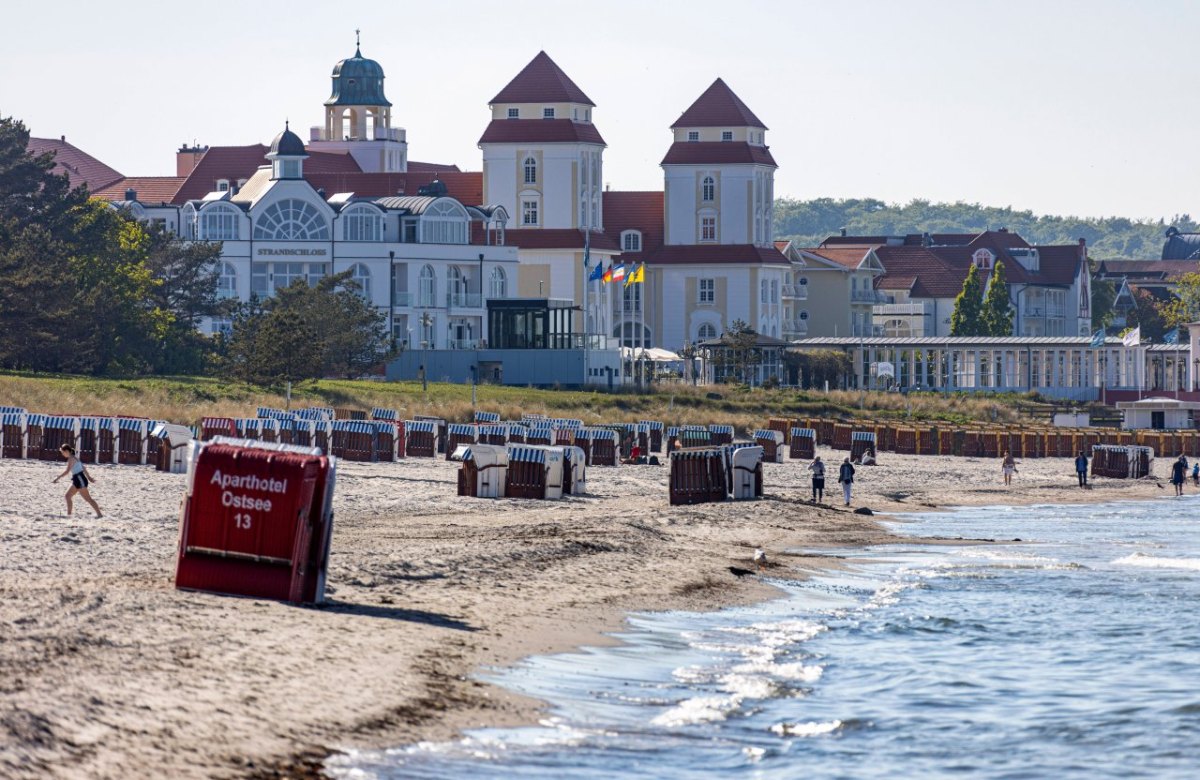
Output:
[{"xmin": 330, "ymin": 497, "xmax": 1200, "ymax": 779}]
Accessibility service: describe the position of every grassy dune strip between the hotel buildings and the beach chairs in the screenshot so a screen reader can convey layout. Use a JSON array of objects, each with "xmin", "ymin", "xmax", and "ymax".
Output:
[{"xmin": 0, "ymin": 373, "xmax": 1036, "ymax": 431}]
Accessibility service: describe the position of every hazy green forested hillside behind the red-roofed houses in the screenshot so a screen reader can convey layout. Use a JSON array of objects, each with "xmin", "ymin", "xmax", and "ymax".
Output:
[{"xmin": 775, "ymin": 198, "xmax": 1200, "ymax": 259}]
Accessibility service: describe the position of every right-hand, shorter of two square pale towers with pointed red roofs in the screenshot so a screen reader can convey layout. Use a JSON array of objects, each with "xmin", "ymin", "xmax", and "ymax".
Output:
[{"xmin": 662, "ymin": 79, "xmax": 776, "ymax": 247}]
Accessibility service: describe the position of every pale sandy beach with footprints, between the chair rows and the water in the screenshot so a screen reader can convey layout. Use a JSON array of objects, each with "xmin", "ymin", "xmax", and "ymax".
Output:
[{"xmin": 0, "ymin": 450, "xmax": 1161, "ymax": 778}]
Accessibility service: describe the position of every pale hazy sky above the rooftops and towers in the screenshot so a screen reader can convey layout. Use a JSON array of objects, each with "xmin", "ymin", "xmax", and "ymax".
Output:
[{"xmin": 0, "ymin": 0, "xmax": 1200, "ymax": 217}]
